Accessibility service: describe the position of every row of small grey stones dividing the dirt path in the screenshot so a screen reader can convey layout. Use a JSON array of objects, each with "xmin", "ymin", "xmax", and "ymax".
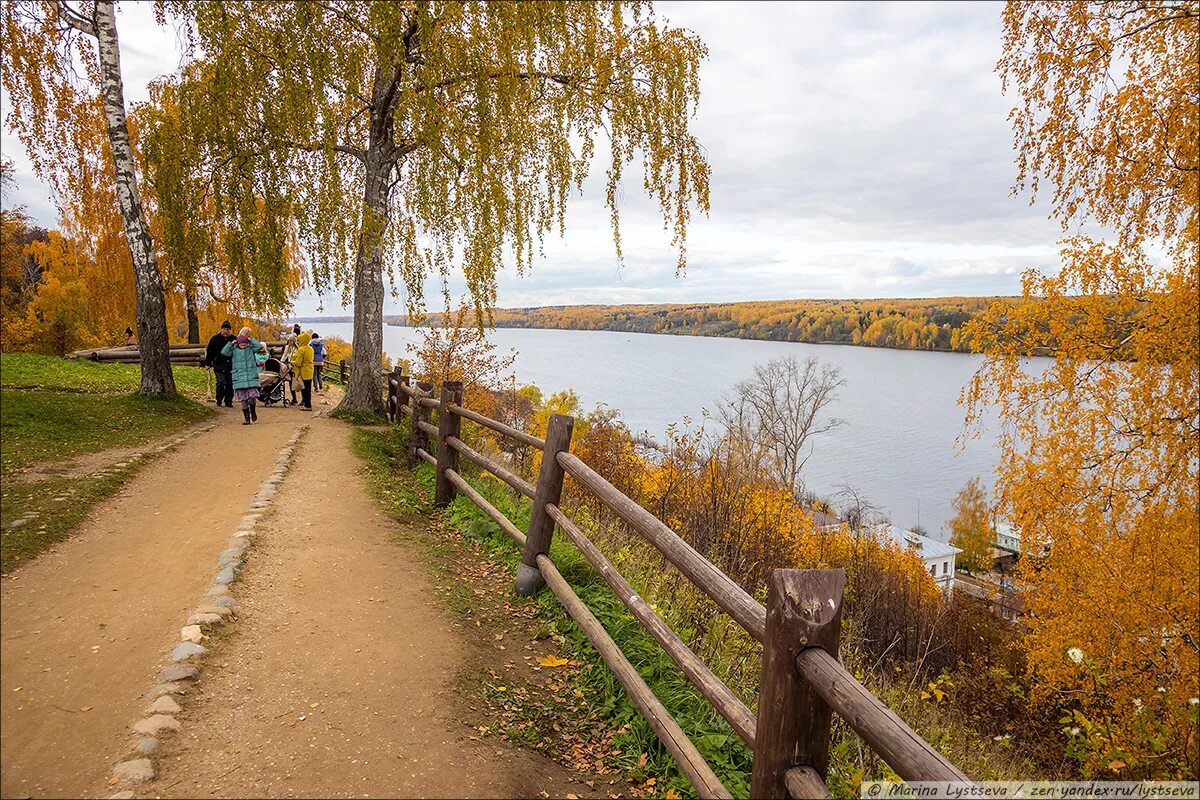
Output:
[{"xmin": 110, "ymin": 423, "xmax": 308, "ymax": 800}]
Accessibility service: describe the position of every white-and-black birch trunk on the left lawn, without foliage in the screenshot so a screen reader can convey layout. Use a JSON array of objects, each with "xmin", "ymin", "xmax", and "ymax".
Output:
[{"xmin": 95, "ymin": 0, "xmax": 175, "ymax": 395}]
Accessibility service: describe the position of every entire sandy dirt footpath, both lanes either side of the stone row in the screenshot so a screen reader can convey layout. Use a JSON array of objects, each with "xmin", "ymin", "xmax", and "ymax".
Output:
[{"xmin": 0, "ymin": 397, "xmax": 592, "ymax": 798}]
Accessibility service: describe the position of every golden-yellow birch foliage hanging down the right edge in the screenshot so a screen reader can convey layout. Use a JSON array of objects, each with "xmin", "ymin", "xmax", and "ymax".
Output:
[{"xmin": 966, "ymin": 1, "xmax": 1200, "ymax": 777}]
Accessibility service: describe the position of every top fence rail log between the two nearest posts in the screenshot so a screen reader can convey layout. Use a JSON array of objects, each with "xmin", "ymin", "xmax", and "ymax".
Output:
[{"xmin": 556, "ymin": 453, "xmax": 767, "ymax": 642}]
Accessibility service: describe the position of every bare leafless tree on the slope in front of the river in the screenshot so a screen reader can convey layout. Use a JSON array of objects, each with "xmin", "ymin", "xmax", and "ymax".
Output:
[{"xmin": 718, "ymin": 356, "xmax": 846, "ymax": 493}]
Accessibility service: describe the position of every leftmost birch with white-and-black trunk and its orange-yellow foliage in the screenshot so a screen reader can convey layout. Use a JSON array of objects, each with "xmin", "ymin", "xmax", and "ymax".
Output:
[{"xmin": 0, "ymin": 0, "xmax": 175, "ymax": 395}]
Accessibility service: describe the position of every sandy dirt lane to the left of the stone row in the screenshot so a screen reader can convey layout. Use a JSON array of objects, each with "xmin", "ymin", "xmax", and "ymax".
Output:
[{"xmin": 0, "ymin": 409, "xmax": 307, "ymax": 798}]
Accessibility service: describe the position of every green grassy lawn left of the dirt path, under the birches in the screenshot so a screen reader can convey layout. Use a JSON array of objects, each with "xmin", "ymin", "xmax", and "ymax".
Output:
[{"xmin": 0, "ymin": 353, "xmax": 212, "ymax": 572}]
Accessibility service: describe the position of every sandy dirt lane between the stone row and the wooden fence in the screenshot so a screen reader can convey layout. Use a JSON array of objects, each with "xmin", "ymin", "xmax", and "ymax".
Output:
[{"xmin": 142, "ymin": 417, "xmax": 592, "ymax": 798}]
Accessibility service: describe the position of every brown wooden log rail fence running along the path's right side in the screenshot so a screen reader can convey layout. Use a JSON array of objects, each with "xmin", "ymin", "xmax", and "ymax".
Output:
[{"xmin": 379, "ymin": 365, "xmax": 968, "ymax": 798}]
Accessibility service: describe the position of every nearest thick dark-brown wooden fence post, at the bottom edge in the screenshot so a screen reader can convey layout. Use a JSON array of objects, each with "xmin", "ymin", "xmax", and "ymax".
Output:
[{"xmin": 750, "ymin": 570, "xmax": 846, "ymax": 798}]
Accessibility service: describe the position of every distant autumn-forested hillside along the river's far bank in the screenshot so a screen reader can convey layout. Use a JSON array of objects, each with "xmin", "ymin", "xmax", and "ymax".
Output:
[{"xmin": 389, "ymin": 297, "xmax": 1018, "ymax": 353}]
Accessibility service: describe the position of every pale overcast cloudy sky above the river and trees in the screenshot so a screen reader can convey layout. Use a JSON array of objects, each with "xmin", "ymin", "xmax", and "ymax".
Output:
[{"xmin": 0, "ymin": 0, "xmax": 1060, "ymax": 314}]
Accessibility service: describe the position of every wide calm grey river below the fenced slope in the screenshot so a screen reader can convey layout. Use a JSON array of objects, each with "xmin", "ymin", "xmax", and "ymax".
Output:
[{"xmin": 305, "ymin": 323, "xmax": 1048, "ymax": 541}]
